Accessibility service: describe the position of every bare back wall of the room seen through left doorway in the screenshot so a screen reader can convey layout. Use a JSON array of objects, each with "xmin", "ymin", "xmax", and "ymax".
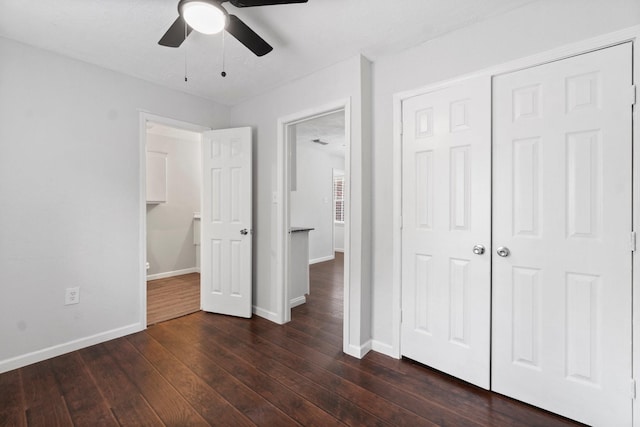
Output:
[{"xmin": 147, "ymin": 128, "xmax": 202, "ymax": 275}]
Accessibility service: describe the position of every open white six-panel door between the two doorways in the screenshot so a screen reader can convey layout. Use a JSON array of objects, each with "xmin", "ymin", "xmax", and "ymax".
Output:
[{"xmin": 200, "ymin": 127, "xmax": 252, "ymax": 317}]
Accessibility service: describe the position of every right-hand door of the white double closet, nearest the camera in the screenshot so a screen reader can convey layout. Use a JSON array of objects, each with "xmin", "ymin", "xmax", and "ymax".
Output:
[{"xmin": 492, "ymin": 43, "xmax": 632, "ymax": 426}]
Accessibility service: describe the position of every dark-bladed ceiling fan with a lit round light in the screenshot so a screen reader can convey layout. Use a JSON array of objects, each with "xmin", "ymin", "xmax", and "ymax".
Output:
[{"xmin": 158, "ymin": 0, "xmax": 308, "ymax": 56}]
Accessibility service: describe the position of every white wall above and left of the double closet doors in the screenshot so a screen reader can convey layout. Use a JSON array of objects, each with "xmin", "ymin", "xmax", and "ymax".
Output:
[{"xmin": 372, "ymin": 0, "xmax": 640, "ymax": 350}]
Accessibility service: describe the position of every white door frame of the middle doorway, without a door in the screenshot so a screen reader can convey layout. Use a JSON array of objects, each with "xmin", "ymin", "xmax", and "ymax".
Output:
[{"xmin": 271, "ymin": 99, "xmax": 359, "ymax": 334}]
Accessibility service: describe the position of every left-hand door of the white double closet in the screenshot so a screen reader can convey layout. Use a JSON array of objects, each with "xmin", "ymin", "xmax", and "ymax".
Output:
[{"xmin": 401, "ymin": 77, "xmax": 491, "ymax": 388}]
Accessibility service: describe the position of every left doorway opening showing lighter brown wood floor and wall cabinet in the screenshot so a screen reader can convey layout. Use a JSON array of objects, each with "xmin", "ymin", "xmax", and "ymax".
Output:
[{"xmin": 140, "ymin": 113, "xmax": 210, "ymax": 326}]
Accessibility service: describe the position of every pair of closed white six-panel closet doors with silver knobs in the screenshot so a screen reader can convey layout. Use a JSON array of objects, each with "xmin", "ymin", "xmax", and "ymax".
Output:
[{"xmin": 401, "ymin": 43, "xmax": 632, "ymax": 425}]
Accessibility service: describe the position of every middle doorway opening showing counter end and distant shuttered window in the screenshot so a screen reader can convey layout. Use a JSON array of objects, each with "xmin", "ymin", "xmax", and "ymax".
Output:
[{"xmin": 287, "ymin": 109, "xmax": 347, "ymax": 323}]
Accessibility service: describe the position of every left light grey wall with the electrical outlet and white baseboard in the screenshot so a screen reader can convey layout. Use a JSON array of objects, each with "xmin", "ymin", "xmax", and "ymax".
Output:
[{"xmin": 0, "ymin": 38, "xmax": 228, "ymax": 372}]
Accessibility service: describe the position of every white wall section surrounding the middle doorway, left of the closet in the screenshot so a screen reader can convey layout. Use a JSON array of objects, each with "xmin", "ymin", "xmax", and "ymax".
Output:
[{"xmin": 231, "ymin": 57, "xmax": 371, "ymax": 356}]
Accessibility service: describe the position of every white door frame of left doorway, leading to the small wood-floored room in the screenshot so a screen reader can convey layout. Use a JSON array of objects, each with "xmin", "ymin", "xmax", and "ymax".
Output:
[{"xmin": 138, "ymin": 111, "xmax": 212, "ymax": 330}]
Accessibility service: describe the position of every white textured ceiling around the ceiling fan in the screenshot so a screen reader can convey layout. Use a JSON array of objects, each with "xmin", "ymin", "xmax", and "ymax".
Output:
[{"xmin": 0, "ymin": 0, "xmax": 535, "ymax": 105}]
